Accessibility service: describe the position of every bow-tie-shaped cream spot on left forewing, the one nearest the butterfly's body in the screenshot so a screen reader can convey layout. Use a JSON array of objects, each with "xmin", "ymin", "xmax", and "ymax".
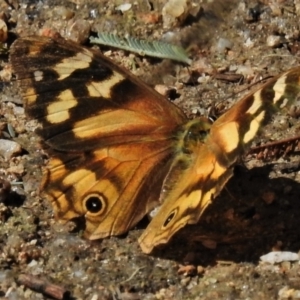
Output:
[{"xmin": 86, "ymin": 72, "xmax": 125, "ymax": 99}]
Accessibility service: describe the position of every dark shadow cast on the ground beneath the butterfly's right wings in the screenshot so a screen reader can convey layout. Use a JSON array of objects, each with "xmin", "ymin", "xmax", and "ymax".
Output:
[{"xmin": 149, "ymin": 165, "xmax": 300, "ymax": 266}]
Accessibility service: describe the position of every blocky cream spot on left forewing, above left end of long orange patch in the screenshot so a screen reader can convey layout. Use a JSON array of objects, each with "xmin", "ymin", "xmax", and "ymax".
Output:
[{"xmin": 47, "ymin": 90, "xmax": 78, "ymax": 124}]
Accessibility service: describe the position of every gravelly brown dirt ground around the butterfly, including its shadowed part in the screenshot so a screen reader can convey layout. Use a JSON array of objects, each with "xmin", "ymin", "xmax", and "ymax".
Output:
[{"xmin": 0, "ymin": 0, "xmax": 300, "ymax": 300}]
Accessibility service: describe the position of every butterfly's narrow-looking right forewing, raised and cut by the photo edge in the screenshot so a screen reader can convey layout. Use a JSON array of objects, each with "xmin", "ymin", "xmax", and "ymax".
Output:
[{"xmin": 208, "ymin": 67, "xmax": 300, "ymax": 166}]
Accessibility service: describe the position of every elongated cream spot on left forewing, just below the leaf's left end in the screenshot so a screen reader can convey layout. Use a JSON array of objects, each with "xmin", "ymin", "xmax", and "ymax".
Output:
[{"xmin": 53, "ymin": 51, "xmax": 92, "ymax": 80}]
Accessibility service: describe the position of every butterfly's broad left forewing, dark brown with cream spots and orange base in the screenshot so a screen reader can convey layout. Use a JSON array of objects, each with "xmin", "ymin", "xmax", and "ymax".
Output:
[{"xmin": 11, "ymin": 37, "xmax": 185, "ymax": 151}]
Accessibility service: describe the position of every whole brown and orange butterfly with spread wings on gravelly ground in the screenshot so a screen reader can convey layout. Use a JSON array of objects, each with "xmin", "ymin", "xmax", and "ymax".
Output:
[{"xmin": 11, "ymin": 36, "xmax": 300, "ymax": 253}]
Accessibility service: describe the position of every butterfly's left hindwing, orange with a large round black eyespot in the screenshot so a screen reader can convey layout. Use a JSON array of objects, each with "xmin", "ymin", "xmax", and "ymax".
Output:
[{"xmin": 44, "ymin": 144, "xmax": 175, "ymax": 239}]
